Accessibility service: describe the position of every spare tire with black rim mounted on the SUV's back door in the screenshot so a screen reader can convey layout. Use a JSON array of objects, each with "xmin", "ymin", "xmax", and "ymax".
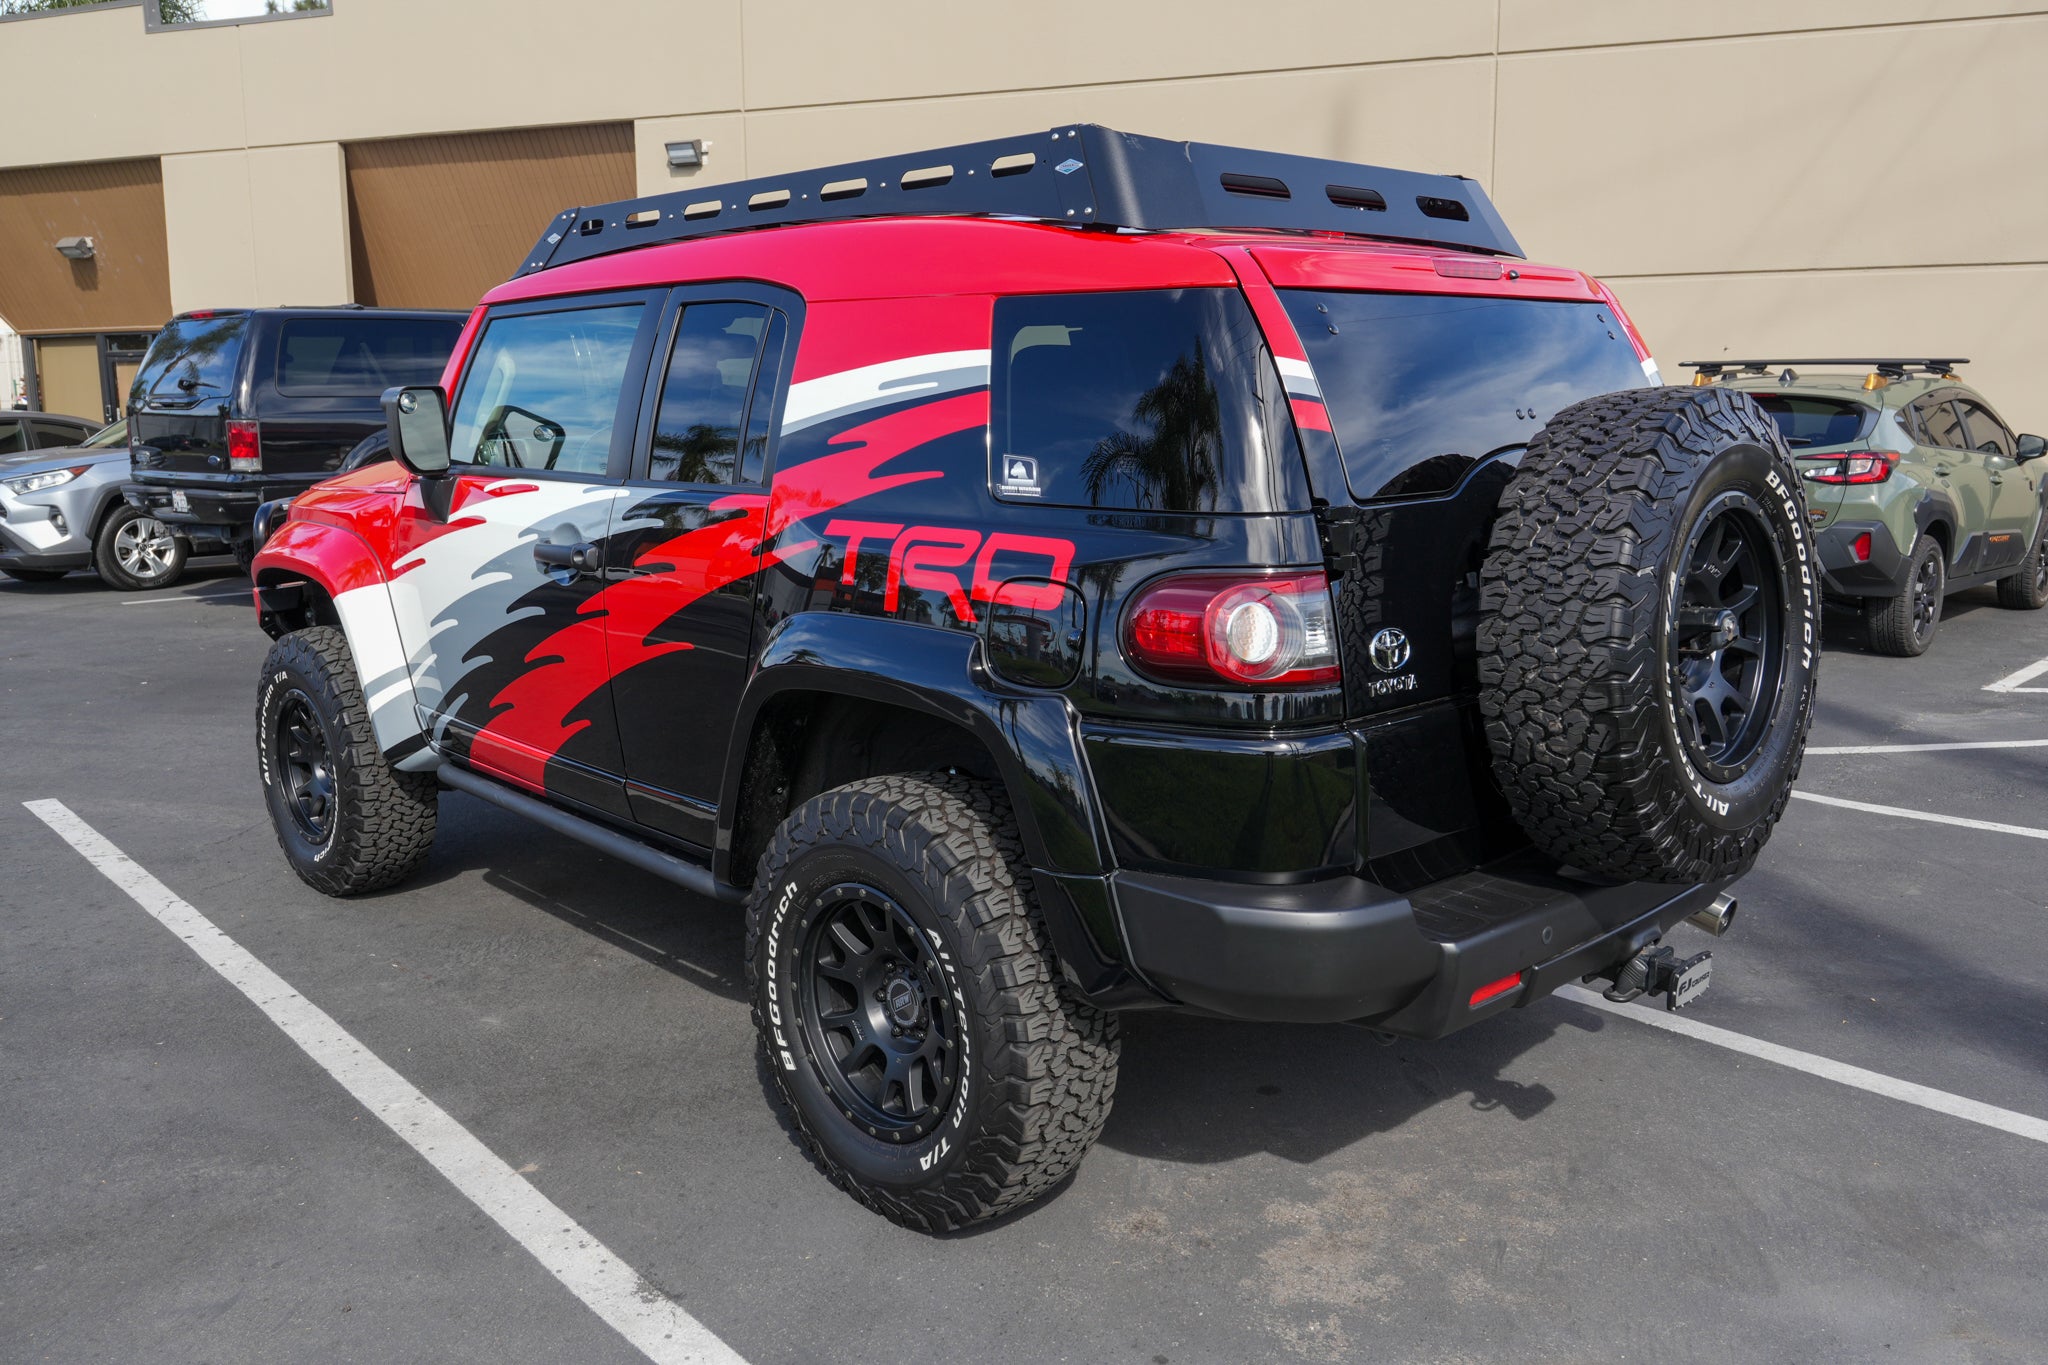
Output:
[{"xmin": 1479, "ymin": 389, "xmax": 1821, "ymax": 882}]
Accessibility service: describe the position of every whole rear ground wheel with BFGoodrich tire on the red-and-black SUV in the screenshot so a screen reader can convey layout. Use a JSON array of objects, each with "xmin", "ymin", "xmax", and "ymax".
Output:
[{"xmin": 748, "ymin": 774, "xmax": 1116, "ymax": 1232}]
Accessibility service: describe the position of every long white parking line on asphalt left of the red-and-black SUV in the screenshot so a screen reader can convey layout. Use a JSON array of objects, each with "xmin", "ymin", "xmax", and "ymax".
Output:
[{"xmin": 23, "ymin": 800, "xmax": 745, "ymax": 1365}]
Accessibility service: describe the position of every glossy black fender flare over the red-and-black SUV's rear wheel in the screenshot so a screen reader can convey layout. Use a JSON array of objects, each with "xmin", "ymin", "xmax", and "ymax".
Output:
[{"xmin": 713, "ymin": 612, "xmax": 1124, "ymax": 995}]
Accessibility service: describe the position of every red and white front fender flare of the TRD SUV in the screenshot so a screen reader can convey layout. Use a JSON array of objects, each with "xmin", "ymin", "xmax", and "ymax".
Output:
[{"xmin": 252, "ymin": 520, "xmax": 436, "ymax": 772}]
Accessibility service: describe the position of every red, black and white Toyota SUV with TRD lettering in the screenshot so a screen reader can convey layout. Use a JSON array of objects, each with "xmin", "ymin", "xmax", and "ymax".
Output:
[{"xmin": 256, "ymin": 127, "xmax": 1819, "ymax": 1230}]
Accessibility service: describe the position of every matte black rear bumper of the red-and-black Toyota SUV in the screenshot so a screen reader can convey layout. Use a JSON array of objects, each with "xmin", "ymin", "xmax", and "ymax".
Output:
[{"xmin": 1114, "ymin": 851, "xmax": 1729, "ymax": 1038}]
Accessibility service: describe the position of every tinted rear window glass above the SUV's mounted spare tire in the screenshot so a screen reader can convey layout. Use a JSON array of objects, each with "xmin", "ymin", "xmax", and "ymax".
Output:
[{"xmin": 1280, "ymin": 289, "xmax": 1645, "ymax": 497}]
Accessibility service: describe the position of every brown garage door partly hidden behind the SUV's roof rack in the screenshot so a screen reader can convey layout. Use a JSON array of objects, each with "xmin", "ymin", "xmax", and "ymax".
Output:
[{"xmin": 348, "ymin": 123, "xmax": 633, "ymax": 309}]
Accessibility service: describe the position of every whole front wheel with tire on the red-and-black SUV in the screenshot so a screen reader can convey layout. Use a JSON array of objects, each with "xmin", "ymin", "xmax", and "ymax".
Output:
[{"xmin": 256, "ymin": 626, "xmax": 440, "ymax": 896}]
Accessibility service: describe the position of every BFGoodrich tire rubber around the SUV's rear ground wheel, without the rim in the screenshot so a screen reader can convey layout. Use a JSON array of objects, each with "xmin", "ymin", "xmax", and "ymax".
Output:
[{"xmin": 748, "ymin": 774, "xmax": 1118, "ymax": 1232}]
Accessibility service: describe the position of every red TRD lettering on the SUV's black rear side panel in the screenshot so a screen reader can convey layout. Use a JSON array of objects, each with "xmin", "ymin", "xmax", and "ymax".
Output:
[{"xmin": 825, "ymin": 520, "xmax": 1073, "ymax": 626}]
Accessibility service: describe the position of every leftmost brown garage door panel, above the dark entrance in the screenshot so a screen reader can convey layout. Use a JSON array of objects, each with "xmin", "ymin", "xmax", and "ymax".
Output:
[{"xmin": 0, "ymin": 159, "xmax": 169, "ymax": 335}]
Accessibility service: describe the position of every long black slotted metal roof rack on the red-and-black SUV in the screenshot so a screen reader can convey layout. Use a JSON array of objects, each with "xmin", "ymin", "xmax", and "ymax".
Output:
[{"xmin": 518, "ymin": 123, "xmax": 1522, "ymax": 274}]
